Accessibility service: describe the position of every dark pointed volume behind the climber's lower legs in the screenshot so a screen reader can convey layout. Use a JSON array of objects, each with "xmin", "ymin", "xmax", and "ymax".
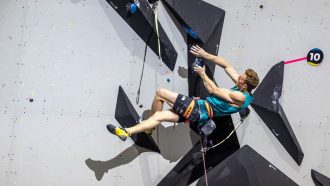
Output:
[{"xmin": 115, "ymin": 86, "xmax": 160, "ymax": 152}]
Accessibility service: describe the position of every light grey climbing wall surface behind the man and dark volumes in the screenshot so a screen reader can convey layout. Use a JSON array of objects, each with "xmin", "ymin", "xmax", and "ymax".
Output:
[{"xmin": 0, "ymin": 0, "xmax": 330, "ymax": 186}]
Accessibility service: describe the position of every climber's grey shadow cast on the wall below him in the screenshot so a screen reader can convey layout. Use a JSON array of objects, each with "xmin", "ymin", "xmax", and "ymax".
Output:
[{"xmin": 85, "ymin": 123, "xmax": 199, "ymax": 181}]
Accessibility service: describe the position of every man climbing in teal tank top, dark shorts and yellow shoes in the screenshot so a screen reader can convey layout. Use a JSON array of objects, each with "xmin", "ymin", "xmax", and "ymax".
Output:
[{"xmin": 107, "ymin": 45, "xmax": 259, "ymax": 141}]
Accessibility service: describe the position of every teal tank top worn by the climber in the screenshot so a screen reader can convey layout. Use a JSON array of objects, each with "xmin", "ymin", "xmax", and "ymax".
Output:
[{"xmin": 201, "ymin": 86, "xmax": 253, "ymax": 119}]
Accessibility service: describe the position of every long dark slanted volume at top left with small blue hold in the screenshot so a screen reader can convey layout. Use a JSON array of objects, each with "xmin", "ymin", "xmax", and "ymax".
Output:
[{"xmin": 107, "ymin": 0, "xmax": 177, "ymax": 71}]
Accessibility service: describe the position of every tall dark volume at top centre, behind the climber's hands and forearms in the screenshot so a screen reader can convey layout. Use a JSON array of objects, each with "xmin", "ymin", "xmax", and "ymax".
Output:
[{"xmin": 163, "ymin": 0, "xmax": 225, "ymax": 98}]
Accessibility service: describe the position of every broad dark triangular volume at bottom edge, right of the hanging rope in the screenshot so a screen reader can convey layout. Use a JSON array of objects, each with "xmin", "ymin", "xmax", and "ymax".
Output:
[{"xmin": 197, "ymin": 145, "xmax": 298, "ymax": 186}]
